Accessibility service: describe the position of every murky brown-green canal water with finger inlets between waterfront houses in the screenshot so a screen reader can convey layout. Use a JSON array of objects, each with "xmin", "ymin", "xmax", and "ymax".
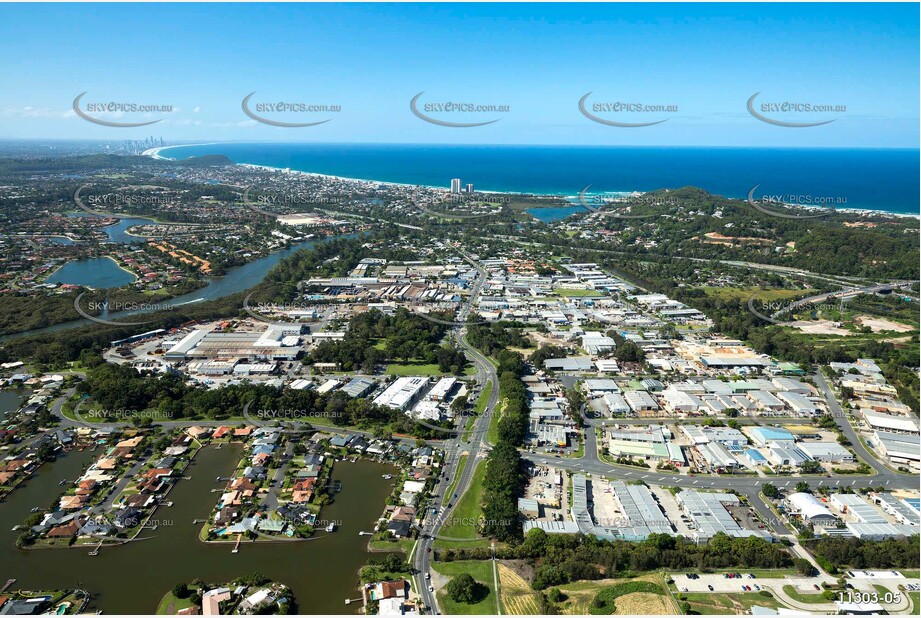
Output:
[{"xmin": 0, "ymin": 445, "xmax": 394, "ymax": 614}]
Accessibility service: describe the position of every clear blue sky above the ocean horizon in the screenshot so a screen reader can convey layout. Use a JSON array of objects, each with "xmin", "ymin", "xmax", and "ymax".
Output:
[{"xmin": 0, "ymin": 3, "xmax": 919, "ymax": 148}]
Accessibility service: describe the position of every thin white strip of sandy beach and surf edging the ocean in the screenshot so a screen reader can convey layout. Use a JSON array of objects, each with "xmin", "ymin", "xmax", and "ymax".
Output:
[{"xmin": 141, "ymin": 142, "xmax": 921, "ymax": 220}]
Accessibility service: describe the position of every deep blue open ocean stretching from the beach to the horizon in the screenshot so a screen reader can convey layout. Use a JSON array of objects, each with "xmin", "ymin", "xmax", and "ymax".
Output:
[{"xmin": 160, "ymin": 142, "xmax": 919, "ymax": 216}]
